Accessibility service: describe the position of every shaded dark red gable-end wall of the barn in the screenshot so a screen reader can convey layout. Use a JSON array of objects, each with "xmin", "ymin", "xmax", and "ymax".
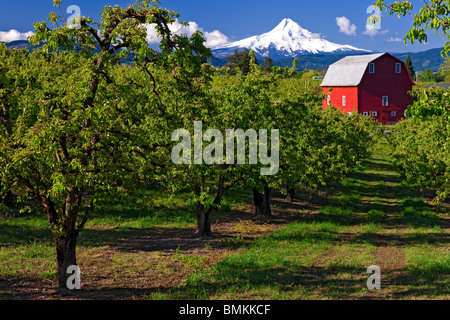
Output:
[{"xmin": 359, "ymin": 55, "xmax": 413, "ymax": 123}]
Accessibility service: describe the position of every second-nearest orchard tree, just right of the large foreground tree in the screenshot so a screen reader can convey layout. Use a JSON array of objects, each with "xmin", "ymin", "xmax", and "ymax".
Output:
[{"xmin": 164, "ymin": 52, "xmax": 284, "ymax": 237}]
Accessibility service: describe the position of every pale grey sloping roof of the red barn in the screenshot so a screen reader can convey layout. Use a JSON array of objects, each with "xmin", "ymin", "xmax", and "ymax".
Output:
[{"xmin": 320, "ymin": 53, "xmax": 387, "ymax": 87}]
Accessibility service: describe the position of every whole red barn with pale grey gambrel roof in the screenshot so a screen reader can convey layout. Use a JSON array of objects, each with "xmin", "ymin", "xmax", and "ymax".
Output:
[{"xmin": 320, "ymin": 53, "xmax": 414, "ymax": 124}]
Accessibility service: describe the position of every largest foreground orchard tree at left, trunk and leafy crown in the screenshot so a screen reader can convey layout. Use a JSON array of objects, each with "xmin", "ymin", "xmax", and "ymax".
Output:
[{"xmin": 0, "ymin": 1, "xmax": 210, "ymax": 290}]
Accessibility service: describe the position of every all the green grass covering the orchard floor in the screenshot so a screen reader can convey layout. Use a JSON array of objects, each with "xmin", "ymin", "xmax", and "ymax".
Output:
[{"xmin": 0, "ymin": 141, "xmax": 450, "ymax": 300}]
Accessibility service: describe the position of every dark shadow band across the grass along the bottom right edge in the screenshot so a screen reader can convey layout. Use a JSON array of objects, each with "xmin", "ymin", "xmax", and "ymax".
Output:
[{"xmin": 159, "ymin": 262, "xmax": 449, "ymax": 300}]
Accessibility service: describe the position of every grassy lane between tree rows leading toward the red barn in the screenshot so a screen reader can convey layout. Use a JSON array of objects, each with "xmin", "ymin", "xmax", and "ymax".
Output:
[{"xmin": 158, "ymin": 138, "xmax": 450, "ymax": 299}]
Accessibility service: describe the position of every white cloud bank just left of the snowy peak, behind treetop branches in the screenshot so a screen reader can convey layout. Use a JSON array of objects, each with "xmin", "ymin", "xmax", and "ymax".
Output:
[{"xmin": 147, "ymin": 21, "xmax": 229, "ymax": 49}]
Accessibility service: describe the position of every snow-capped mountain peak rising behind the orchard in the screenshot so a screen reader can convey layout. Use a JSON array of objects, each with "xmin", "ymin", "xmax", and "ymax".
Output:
[{"xmin": 213, "ymin": 19, "xmax": 371, "ymax": 59}]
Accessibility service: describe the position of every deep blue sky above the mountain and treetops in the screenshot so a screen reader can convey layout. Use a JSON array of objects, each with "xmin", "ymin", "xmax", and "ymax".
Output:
[{"xmin": 0, "ymin": 0, "xmax": 444, "ymax": 52}]
